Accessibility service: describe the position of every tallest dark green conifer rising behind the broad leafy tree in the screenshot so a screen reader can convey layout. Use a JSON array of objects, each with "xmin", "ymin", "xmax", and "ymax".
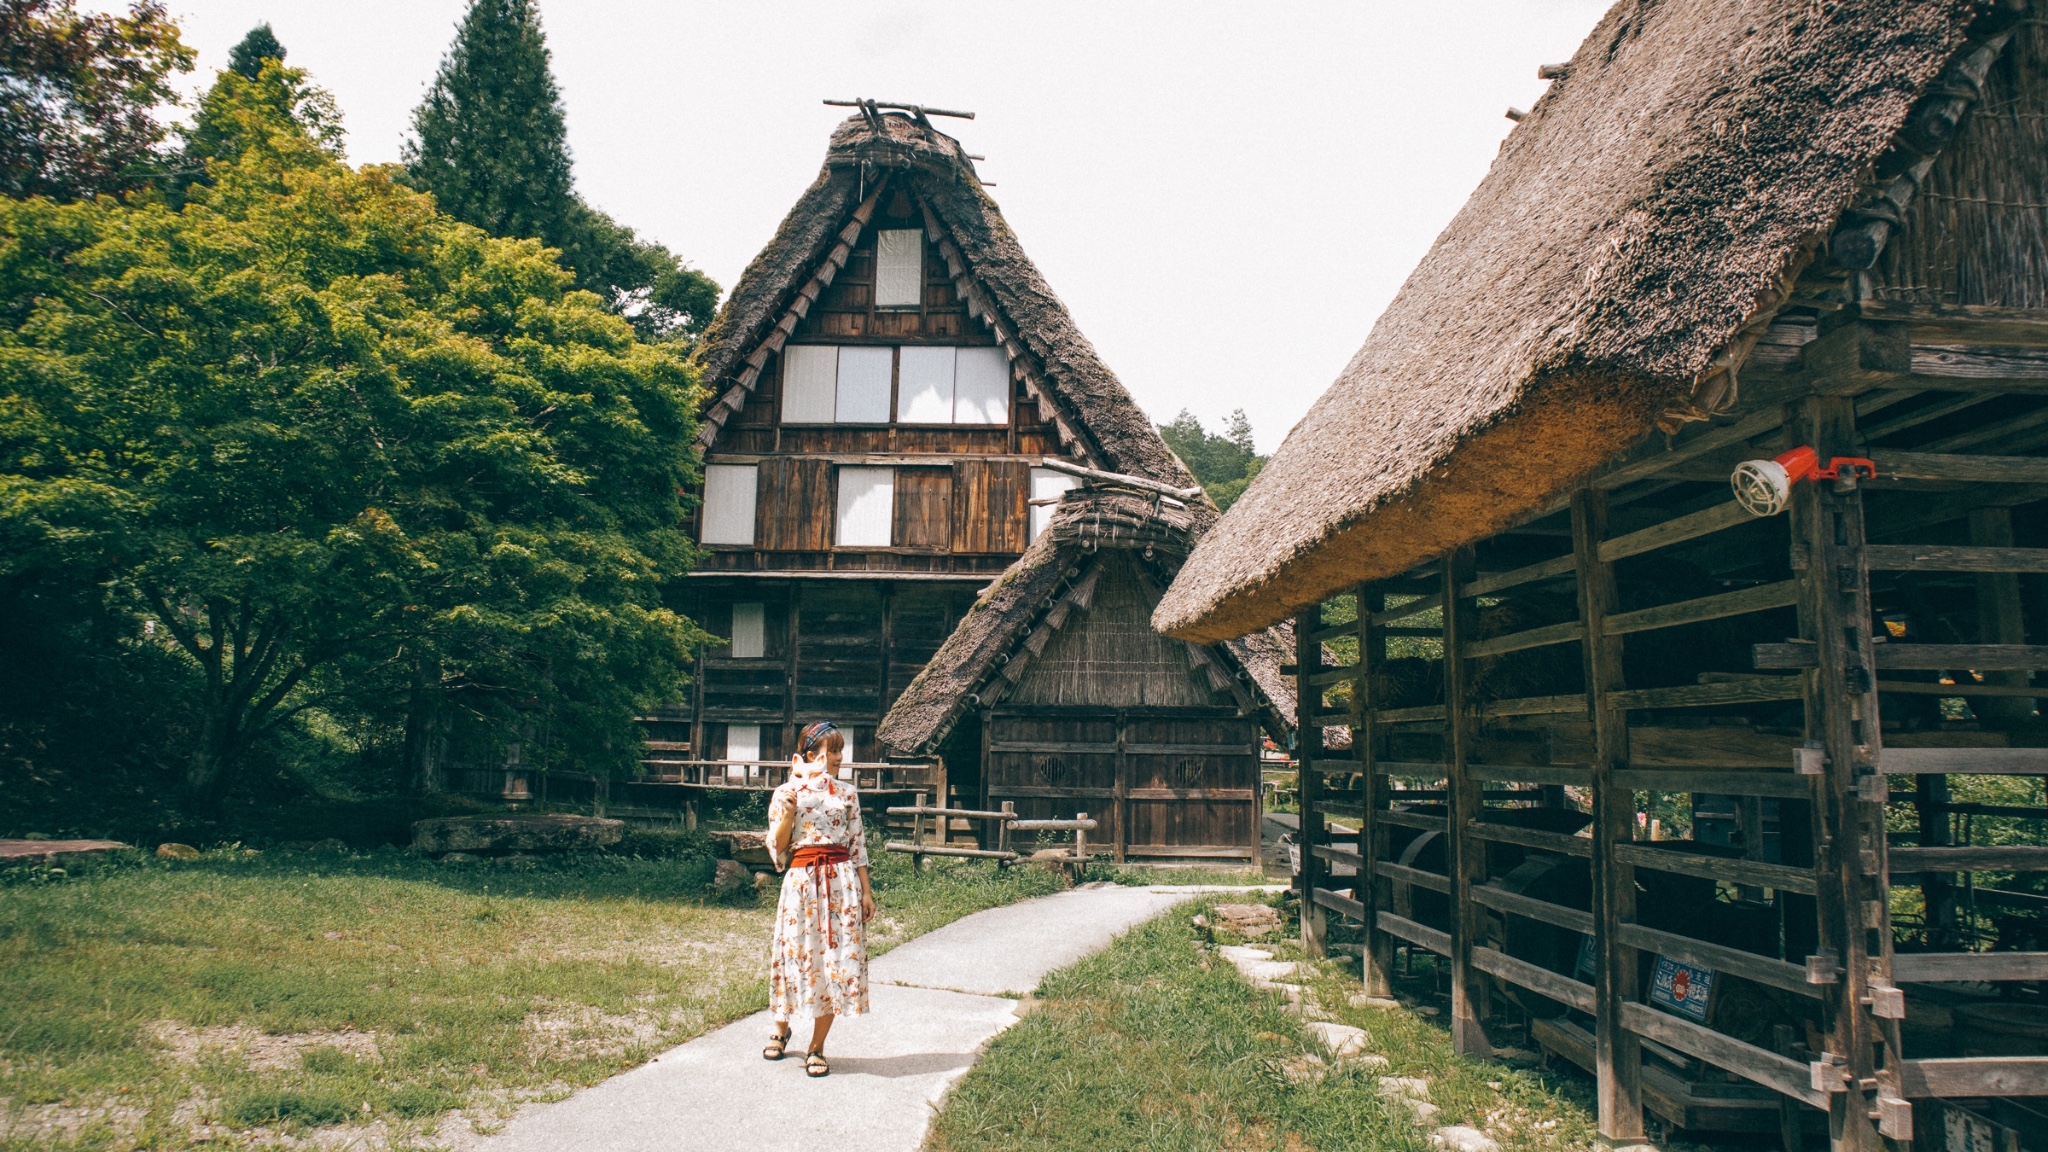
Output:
[{"xmin": 406, "ymin": 0, "xmax": 719, "ymax": 340}]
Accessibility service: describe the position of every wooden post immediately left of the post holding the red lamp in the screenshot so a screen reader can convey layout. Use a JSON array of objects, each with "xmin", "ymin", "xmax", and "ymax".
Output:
[{"xmin": 1571, "ymin": 488, "xmax": 1642, "ymax": 1140}]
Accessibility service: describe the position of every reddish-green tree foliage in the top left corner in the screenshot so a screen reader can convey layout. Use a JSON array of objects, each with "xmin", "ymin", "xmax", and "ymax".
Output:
[{"xmin": 0, "ymin": 0, "xmax": 193, "ymax": 201}]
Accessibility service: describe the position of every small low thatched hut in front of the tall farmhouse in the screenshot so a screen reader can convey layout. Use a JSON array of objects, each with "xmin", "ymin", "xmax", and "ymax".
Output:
[{"xmin": 881, "ymin": 482, "xmax": 1292, "ymax": 861}]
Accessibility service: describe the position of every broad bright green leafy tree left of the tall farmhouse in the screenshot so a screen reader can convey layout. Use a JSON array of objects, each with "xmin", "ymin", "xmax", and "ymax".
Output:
[{"xmin": 0, "ymin": 73, "xmax": 696, "ymax": 799}]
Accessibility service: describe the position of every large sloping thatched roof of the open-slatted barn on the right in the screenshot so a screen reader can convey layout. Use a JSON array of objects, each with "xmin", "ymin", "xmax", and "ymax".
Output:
[{"xmin": 1155, "ymin": 0, "xmax": 2013, "ymax": 640}]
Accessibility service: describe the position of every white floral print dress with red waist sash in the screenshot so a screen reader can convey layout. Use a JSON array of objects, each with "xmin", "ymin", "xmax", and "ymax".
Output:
[{"xmin": 768, "ymin": 763, "xmax": 868, "ymax": 1021}]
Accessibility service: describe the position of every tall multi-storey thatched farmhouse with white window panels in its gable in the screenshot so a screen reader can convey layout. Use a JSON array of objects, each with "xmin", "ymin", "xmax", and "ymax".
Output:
[{"xmin": 675, "ymin": 105, "xmax": 1194, "ymax": 778}]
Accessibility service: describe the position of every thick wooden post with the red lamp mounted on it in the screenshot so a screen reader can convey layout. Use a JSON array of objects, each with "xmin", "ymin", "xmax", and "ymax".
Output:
[{"xmin": 1792, "ymin": 396, "xmax": 1911, "ymax": 1152}]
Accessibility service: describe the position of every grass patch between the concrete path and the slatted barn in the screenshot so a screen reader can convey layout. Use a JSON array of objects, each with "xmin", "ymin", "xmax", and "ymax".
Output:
[{"xmin": 928, "ymin": 908, "xmax": 1595, "ymax": 1152}]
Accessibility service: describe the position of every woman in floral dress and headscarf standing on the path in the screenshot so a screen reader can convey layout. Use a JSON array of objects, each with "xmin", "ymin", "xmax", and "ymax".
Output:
[{"xmin": 762, "ymin": 719, "xmax": 874, "ymax": 1076}]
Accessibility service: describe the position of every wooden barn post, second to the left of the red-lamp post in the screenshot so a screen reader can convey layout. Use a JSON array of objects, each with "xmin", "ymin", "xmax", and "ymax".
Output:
[{"xmin": 1442, "ymin": 547, "xmax": 1493, "ymax": 1058}]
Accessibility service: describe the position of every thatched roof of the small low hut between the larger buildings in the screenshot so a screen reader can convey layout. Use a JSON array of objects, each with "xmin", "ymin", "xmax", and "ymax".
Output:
[{"xmin": 874, "ymin": 486, "xmax": 1294, "ymax": 756}]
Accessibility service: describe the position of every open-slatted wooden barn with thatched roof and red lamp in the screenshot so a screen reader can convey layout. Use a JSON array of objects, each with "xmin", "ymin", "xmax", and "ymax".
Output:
[{"xmin": 1155, "ymin": 0, "xmax": 2048, "ymax": 1150}]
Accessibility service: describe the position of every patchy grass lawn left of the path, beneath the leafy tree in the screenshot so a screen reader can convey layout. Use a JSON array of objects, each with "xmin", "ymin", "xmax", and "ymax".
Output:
[{"xmin": 0, "ymin": 828, "xmax": 1061, "ymax": 1152}]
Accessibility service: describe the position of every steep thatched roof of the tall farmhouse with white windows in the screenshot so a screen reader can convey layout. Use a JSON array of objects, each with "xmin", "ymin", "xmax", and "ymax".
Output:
[{"xmin": 698, "ymin": 115, "xmax": 1194, "ymax": 486}]
